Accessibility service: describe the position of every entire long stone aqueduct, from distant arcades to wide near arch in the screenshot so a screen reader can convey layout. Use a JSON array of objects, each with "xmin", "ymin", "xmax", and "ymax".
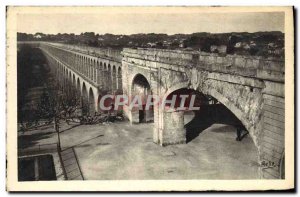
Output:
[{"xmin": 20, "ymin": 42, "xmax": 285, "ymax": 178}]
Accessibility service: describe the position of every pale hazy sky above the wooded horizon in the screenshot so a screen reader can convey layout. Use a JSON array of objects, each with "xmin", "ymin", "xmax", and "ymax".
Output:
[{"xmin": 17, "ymin": 9, "xmax": 284, "ymax": 35}]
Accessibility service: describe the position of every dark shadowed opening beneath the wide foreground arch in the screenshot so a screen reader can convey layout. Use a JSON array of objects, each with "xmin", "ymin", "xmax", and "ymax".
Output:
[{"xmin": 167, "ymin": 88, "xmax": 248, "ymax": 143}]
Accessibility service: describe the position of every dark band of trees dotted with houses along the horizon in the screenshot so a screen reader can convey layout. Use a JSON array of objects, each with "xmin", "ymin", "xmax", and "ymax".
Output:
[{"xmin": 17, "ymin": 31, "xmax": 284, "ymax": 58}]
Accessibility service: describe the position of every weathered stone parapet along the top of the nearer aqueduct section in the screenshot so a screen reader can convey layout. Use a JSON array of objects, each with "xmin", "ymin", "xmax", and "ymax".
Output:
[{"xmin": 122, "ymin": 48, "xmax": 285, "ymax": 82}]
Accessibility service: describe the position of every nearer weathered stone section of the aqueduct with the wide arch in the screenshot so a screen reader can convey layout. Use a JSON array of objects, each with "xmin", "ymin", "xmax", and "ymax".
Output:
[{"xmin": 122, "ymin": 49, "xmax": 285, "ymax": 178}]
